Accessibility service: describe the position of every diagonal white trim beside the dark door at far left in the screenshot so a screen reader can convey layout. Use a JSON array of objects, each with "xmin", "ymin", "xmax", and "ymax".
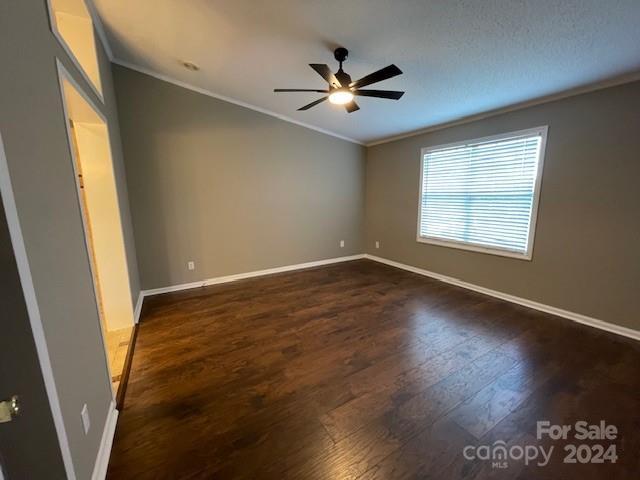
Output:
[{"xmin": 0, "ymin": 135, "xmax": 76, "ymax": 480}]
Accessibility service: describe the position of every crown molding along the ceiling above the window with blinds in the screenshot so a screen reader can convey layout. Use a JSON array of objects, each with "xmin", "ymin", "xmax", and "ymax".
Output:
[{"xmin": 364, "ymin": 71, "xmax": 640, "ymax": 147}]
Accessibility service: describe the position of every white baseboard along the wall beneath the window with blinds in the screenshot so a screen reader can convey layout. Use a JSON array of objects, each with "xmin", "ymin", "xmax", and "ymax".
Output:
[{"xmin": 364, "ymin": 254, "xmax": 640, "ymax": 340}]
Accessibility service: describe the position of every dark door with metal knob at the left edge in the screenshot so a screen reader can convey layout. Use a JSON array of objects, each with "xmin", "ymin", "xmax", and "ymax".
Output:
[{"xmin": 0, "ymin": 148, "xmax": 66, "ymax": 474}]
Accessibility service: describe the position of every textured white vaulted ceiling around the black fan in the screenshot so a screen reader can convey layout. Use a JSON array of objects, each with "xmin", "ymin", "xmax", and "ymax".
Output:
[{"xmin": 94, "ymin": 0, "xmax": 640, "ymax": 143}]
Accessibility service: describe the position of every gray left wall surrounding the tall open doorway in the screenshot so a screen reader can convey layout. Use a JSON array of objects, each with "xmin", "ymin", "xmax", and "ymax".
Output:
[{"xmin": 0, "ymin": 0, "xmax": 139, "ymax": 478}]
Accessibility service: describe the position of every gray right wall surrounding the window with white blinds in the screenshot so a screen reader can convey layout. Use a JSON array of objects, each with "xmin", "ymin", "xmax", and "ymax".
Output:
[{"xmin": 366, "ymin": 82, "xmax": 640, "ymax": 329}]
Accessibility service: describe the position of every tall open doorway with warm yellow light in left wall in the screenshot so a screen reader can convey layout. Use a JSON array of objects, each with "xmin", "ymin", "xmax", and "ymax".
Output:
[{"xmin": 58, "ymin": 63, "xmax": 134, "ymax": 394}]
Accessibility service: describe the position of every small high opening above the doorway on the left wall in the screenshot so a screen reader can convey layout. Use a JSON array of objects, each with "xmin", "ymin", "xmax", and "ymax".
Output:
[{"xmin": 48, "ymin": 0, "xmax": 103, "ymax": 100}]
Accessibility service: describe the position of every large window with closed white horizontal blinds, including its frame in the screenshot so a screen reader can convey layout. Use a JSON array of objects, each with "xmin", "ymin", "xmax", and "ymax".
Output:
[{"xmin": 417, "ymin": 127, "xmax": 547, "ymax": 259}]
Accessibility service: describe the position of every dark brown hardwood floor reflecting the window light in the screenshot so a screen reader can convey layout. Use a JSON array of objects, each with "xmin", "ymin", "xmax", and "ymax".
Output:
[{"xmin": 108, "ymin": 260, "xmax": 640, "ymax": 480}]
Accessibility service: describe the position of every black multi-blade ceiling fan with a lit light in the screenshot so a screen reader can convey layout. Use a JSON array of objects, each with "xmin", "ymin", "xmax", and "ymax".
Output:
[{"xmin": 274, "ymin": 47, "xmax": 404, "ymax": 113}]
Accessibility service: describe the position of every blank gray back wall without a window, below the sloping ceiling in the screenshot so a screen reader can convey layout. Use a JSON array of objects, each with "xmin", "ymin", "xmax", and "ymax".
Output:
[{"xmin": 114, "ymin": 66, "xmax": 364, "ymax": 289}]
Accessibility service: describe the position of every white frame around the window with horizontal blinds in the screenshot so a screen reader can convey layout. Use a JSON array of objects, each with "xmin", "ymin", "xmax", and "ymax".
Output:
[{"xmin": 416, "ymin": 125, "xmax": 549, "ymax": 261}]
